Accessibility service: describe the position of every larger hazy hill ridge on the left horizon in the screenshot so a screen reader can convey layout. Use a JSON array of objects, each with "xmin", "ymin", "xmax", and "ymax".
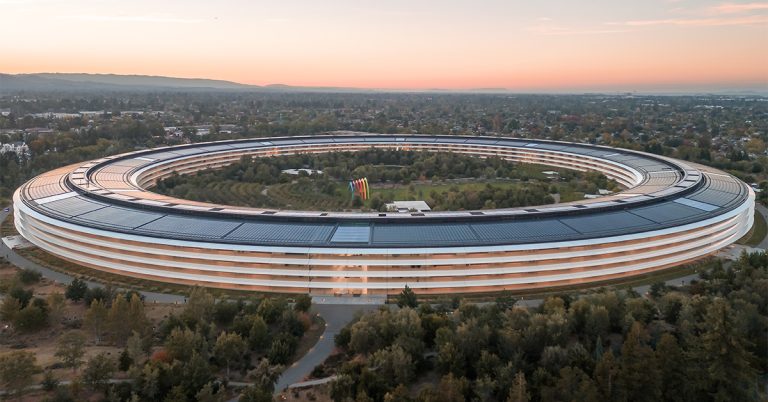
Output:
[{"xmin": 0, "ymin": 73, "xmax": 370, "ymax": 93}]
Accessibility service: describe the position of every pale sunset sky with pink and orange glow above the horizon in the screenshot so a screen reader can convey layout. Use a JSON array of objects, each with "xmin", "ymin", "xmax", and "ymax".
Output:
[{"xmin": 0, "ymin": 0, "xmax": 768, "ymax": 92}]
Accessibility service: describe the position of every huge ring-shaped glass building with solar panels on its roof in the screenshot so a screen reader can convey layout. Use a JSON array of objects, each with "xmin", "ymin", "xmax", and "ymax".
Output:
[{"xmin": 14, "ymin": 133, "xmax": 755, "ymax": 295}]
